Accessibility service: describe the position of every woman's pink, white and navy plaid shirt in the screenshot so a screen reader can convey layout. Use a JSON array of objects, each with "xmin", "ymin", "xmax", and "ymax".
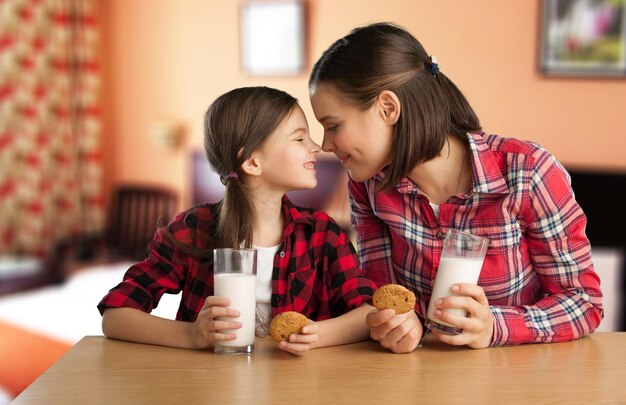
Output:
[{"xmin": 349, "ymin": 133, "xmax": 603, "ymax": 345}]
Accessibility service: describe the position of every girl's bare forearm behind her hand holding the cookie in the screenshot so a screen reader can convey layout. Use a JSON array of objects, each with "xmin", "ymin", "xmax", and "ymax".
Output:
[{"xmin": 313, "ymin": 304, "xmax": 374, "ymax": 348}]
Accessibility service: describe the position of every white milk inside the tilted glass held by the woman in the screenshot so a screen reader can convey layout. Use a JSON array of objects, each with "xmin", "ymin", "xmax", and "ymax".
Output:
[{"xmin": 426, "ymin": 257, "xmax": 483, "ymax": 326}]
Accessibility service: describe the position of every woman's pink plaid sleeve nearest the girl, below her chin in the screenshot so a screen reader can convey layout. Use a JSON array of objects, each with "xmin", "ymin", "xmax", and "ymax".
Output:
[{"xmin": 348, "ymin": 179, "xmax": 395, "ymax": 286}]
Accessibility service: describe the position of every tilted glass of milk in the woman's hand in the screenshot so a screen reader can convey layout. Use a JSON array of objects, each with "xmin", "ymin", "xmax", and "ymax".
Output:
[{"xmin": 426, "ymin": 229, "xmax": 489, "ymax": 335}]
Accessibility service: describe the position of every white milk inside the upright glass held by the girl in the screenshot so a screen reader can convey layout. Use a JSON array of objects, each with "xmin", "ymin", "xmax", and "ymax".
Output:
[{"xmin": 214, "ymin": 273, "xmax": 256, "ymax": 347}]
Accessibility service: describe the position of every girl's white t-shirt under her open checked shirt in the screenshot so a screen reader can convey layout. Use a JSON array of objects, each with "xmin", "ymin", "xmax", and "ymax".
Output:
[{"xmin": 253, "ymin": 245, "xmax": 280, "ymax": 336}]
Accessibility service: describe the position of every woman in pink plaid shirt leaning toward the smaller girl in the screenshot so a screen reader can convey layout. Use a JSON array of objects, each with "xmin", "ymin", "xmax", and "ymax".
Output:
[{"xmin": 309, "ymin": 23, "xmax": 603, "ymax": 352}]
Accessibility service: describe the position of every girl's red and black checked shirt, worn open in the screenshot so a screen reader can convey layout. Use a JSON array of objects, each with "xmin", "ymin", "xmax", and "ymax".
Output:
[{"xmin": 98, "ymin": 197, "xmax": 376, "ymax": 322}]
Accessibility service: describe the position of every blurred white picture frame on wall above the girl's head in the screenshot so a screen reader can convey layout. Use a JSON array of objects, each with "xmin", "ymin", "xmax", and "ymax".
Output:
[{"xmin": 240, "ymin": 0, "xmax": 306, "ymax": 76}]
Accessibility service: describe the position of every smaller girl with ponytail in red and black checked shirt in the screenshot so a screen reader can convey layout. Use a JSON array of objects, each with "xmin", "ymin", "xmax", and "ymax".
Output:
[{"xmin": 98, "ymin": 87, "xmax": 375, "ymax": 355}]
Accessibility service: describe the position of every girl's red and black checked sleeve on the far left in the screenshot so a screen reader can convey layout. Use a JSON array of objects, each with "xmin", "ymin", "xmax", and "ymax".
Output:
[{"xmin": 98, "ymin": 213, "xmax": 191, "ymax": 314}]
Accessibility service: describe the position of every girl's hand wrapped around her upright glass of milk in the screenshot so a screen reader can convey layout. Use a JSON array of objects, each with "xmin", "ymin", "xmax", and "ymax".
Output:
[{"xmin": 190, "ymin": 296, "xmax": 241, "ymax": 349}]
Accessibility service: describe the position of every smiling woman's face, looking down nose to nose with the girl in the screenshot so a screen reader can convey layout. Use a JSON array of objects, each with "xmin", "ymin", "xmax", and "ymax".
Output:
[{"xmin": 311, "ymin": 84, "xmax": 393, "ymax": 181}]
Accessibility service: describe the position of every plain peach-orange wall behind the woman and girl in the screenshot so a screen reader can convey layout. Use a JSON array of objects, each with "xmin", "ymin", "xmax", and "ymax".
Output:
[{"xmin": 100, "ymin": 0, "xmax": 626, "ymax": 207}]
